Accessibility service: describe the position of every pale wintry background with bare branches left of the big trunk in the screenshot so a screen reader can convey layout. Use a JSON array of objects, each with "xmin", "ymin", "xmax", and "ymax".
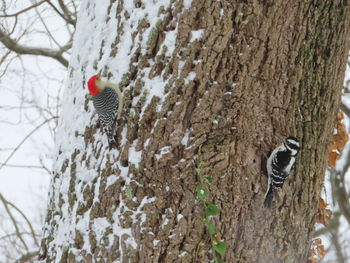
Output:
[{"xmin": 0, "ymin": 0, "xmax": 77, "ymax": 262}]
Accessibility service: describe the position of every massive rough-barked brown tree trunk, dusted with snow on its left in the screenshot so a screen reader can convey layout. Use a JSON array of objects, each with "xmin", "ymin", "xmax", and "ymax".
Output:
[{"xmin": 40, "ymin": 0, "xmax": 349, "ymax": 263}]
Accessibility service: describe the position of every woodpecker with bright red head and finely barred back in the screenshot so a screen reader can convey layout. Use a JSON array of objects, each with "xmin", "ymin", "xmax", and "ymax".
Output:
[{"xmin": 88, "ymin": 75, "xmax": 123, "ymax": 147}]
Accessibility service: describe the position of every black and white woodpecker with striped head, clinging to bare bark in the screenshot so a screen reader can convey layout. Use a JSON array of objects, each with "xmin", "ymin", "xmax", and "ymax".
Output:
[{"xmin": 264, "ymin": 136, "xmax": 300, "ymax": 207}]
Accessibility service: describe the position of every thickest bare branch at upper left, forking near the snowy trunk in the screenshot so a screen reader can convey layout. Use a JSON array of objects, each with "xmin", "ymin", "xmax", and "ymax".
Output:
[{"xmin": 0, "ymin": 29, "xmax": 72, "ymax": 67}]
